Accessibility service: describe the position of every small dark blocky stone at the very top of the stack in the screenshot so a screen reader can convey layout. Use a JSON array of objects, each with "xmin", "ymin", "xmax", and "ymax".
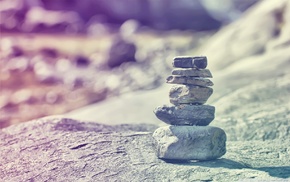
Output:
[{"xmin": 172, "ymin": 56, "xmax": 207, "ymax": 69}]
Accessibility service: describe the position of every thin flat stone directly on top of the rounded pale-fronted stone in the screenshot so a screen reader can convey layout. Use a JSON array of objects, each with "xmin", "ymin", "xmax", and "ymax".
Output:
[{"xmin": 166, "ymin": 75, "xmax": 213, "ymax": 87}]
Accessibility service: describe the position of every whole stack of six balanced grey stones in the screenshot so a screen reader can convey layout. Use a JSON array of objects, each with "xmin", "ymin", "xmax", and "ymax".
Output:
[{"xmin": 153, "ymin": 57, "xmax": 226, "ymax": 160}]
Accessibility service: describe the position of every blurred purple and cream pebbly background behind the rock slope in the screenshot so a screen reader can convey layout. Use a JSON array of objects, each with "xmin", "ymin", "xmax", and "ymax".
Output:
[{"xmin": 0, "ymin": 0, "xmax": 258, "ymax": 128}]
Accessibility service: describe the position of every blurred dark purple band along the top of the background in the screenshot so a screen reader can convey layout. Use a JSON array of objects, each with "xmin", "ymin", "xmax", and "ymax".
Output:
[{"xmin": 0, "ymin": 0, "xmax": 257, "ymax": 33}]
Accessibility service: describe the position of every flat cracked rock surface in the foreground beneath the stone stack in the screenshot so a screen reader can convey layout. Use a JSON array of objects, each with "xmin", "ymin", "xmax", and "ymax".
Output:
[{"xmin": 0, "ymin": 118, "xmax": 290, "ymax": 182}]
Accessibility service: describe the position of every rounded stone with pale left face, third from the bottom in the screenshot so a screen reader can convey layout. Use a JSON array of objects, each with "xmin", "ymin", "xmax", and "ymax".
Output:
[{"xmin": 169, "ymin": 85, "xmax": 213, "ymax": 105}]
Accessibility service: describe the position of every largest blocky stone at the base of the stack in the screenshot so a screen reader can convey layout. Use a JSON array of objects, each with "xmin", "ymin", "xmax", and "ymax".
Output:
[{"xmin": 153, "ymin": 126, "xmax": 226, "ymax": 160}]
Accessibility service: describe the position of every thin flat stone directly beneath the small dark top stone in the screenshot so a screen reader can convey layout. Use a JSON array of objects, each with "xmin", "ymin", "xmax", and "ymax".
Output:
[{"xmin": 171, "ymin": 68, "xmax": 212, "ymax": 78}]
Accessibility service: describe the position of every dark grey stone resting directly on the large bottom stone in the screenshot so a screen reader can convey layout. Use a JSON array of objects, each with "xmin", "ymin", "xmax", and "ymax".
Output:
[{"xmin": 154, "ymin": 104, "xmax": 215, "ymax": 126}]
